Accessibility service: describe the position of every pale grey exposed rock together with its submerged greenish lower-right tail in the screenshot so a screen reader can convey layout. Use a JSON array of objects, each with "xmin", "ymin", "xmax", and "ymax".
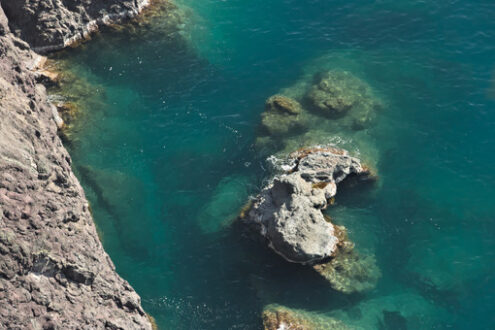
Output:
[{"xmin": 241, "ymin": 147, "xmax": 379, "ymax": 293}]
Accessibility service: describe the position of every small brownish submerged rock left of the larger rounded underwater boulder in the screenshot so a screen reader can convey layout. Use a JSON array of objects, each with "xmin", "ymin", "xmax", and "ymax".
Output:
[{"xmin": 261, "ymin": 95, "xmax": 307, "ymax": 137}]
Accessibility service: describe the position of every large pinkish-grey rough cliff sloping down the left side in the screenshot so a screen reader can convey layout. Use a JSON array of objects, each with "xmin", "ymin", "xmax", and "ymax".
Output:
[{"xmin": 0, "ymin": 0, "xmax": 151, "ymax": 329}]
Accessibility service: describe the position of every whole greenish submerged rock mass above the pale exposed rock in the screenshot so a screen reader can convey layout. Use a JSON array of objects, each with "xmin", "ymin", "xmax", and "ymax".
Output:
[{"xmin": 255, "ymin": 66, "xmax": 383, "ymax": 162}]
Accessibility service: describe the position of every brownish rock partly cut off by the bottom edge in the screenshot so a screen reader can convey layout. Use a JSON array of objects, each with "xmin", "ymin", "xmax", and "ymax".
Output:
[{"xmin": 263, "ymin": 304, "xmax": 354, "ymax": 330}]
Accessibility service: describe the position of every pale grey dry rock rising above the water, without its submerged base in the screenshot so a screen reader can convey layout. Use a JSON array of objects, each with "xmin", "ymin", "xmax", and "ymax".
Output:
[{"xmin": 241, "ymin": 147, "xmax": 369, "ymax": 264}]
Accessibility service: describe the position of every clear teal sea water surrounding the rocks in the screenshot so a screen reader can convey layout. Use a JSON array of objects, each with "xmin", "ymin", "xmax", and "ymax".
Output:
[{"xmin": 51, "ymin": 0, "xmax": 495, "ymax": 329}]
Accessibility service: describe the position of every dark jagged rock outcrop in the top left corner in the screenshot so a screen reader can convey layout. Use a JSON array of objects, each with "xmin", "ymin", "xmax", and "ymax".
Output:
[{"xmin": 0, "ymin": 0, "xmax": 150, "ymax": 52}]
